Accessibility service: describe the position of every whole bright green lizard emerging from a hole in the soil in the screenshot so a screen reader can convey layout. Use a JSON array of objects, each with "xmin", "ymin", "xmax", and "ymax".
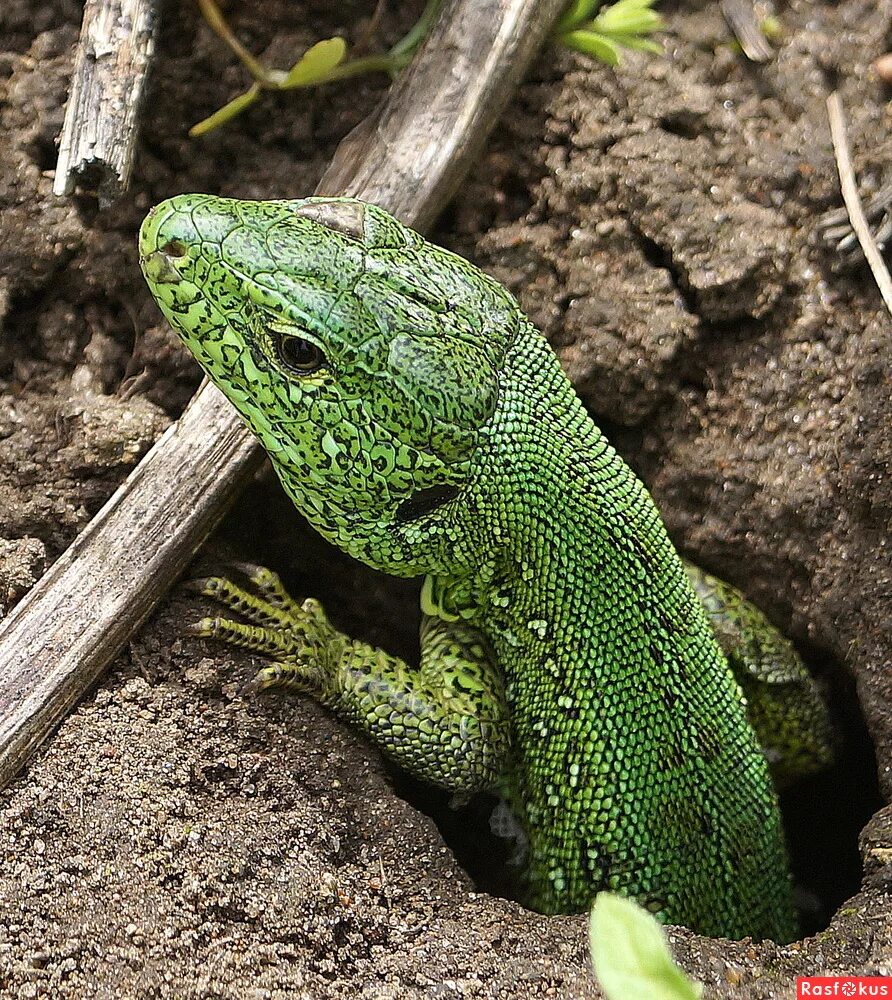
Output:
[{"xmin": 140, "ymin": 195, "xmax": 823, "ymax": 941}]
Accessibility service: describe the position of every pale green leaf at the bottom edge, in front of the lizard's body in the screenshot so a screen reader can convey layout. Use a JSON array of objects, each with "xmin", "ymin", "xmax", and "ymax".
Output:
[{"xmin": 589, "ymin": 892, "xmax": 703, "ymax": 1000}]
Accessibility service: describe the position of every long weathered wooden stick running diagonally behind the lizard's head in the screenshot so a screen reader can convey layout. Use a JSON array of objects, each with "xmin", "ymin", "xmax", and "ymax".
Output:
[{"xmin": 0, "ymin": 0, "xmax": 565, "ymax": 785}]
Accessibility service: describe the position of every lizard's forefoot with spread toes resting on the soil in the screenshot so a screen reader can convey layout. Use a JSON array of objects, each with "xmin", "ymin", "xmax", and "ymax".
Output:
[{"xmin": 186, "ymin": 564, "xmax": 343, "ymax": 702}]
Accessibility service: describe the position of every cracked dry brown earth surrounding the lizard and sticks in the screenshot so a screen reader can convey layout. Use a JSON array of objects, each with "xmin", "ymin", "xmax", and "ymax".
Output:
[{"xmin": 0, "ymin": 0, "xmax": 892, "ymax": 1000}]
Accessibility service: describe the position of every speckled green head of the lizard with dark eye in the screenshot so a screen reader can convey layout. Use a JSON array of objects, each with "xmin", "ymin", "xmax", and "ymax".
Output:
[{"xmin": 140, "ymin": 195, "xmax": 518, "ymax": 575}]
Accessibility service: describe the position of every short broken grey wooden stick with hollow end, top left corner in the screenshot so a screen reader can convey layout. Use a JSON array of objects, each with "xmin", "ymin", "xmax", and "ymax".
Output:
[{"xmin": 53, "ymin": 0, "xmax": 158, "ymax": 204}]
